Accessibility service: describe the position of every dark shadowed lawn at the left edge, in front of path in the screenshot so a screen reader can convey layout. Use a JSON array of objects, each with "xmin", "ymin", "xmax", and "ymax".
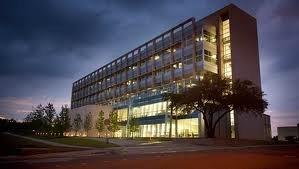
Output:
[{"xmin": 0, "ymin": 133, "xmax": 82, "ymax": 156}]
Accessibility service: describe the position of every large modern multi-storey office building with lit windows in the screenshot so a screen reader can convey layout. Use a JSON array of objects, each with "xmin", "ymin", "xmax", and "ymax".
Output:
[{"xmin": 71, "ymin": 4, "xmax": 271, "ymax": 140}]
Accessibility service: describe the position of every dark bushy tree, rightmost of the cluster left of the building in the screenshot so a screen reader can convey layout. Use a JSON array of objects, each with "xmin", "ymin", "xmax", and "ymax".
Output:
[{"xmin": 54, "ymin": 106, "xmax": 71, "ymax": 136}]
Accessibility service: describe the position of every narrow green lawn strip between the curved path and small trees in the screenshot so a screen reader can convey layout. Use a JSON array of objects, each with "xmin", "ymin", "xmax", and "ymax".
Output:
[{"xmin": 34, "ymin": 136, "xmax": 117, "ymax": 148}]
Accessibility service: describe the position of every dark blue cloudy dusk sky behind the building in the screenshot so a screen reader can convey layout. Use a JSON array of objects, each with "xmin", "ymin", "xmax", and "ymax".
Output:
[{"xmin": 0, "ymin": 0, "xmax": 299, "ymax": 133}]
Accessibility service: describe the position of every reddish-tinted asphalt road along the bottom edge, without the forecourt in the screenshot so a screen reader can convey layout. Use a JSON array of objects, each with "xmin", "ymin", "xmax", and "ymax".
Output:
[{"xmin": 0, "ymin": 146, "xmax": 299, "ymax": 169}]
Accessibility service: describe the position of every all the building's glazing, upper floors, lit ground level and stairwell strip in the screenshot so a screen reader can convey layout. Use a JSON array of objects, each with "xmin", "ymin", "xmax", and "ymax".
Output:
[{"xmin": 71, "ymin": 15, "xmax": 231, "ymax": 137}]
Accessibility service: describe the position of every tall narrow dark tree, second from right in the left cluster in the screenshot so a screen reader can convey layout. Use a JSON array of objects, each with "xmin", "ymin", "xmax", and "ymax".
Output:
[{"xmin": 44, "ymin": 103, "xmax": 56, "ymax": 133}]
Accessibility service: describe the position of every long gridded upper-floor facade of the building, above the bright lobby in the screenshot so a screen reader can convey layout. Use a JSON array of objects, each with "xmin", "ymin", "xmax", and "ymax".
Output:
[{"xmin": 71, "ymin": 18, "xmax": 217, "ymax": 108}]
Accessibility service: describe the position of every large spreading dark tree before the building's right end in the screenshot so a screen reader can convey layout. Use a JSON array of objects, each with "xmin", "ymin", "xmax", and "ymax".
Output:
[{"xmin": 173, "ymin": 73, "xmax": 268, "ymax": 138}]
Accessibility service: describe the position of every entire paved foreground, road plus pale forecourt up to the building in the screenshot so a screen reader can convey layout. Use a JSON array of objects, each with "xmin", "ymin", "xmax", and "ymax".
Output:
[{"xmin": 0, "ymin": 134, "xmax": 299, "ymax": 169}]
